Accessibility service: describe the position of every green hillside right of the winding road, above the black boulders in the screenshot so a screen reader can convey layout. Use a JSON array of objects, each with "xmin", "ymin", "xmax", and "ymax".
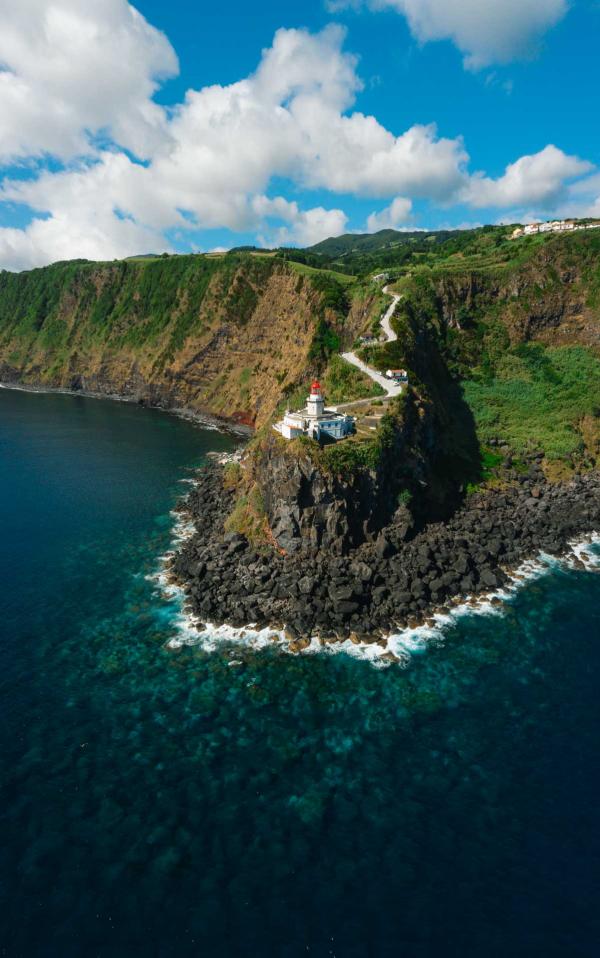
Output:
[{"xmin": 356, "ymin": 231, "xmax": 600, "ymax": 472}]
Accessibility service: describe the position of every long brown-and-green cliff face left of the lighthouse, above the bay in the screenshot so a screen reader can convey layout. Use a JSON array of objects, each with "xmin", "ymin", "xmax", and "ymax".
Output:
[{"xmin": 0, "ymin": 256, "xmax": 337, "ymax": 425}]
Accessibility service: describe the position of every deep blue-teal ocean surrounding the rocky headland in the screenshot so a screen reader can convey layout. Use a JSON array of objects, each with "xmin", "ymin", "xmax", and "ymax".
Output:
[{"xmin": 0, "ymin": 390, "xmax": 600, "ymax": 958}]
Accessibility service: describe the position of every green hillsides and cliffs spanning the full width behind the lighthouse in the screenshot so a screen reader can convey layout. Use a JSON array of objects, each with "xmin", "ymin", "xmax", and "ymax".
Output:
[{"xmin": 0, "ymin": 227, "xmax": 600, "ymax": 484}]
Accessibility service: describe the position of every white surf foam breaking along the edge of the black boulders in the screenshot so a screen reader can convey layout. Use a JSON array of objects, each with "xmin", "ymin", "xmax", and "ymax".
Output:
[{"xmin": 151, "ymin": 512, "xmax": 600, "ymax": 668}]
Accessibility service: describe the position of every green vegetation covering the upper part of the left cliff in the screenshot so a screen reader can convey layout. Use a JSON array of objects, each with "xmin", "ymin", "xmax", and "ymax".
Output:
[{"xmin": 0, "ymin": 255, "xmax": 275, "ymax": 365}]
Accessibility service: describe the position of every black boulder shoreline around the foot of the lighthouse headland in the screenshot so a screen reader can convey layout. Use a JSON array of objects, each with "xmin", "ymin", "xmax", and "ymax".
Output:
[{"xmin": 168, "ymin": 456, "xmax": 600, "ymax": 651}]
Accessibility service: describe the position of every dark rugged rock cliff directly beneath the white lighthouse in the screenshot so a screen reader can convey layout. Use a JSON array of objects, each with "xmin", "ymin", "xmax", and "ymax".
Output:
[{"xmin": 252, "ymin": 394, "xmax": 448, "ymax": 555}]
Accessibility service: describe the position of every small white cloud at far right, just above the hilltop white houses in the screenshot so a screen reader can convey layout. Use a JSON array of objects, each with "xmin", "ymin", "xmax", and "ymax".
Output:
[{"xmin": 463, "ymin": 146, "xmax": 593, "ymax": 207}]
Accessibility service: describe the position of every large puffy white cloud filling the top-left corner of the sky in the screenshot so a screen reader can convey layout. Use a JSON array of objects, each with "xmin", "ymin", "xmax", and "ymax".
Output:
[{"xmin": 0, "ymin": 0, "xmax": 178, "ymax": 161}]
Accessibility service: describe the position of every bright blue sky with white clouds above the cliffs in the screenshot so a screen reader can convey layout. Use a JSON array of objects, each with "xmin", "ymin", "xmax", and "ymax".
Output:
[{"xmin": 0, "ymin": 0, "xmax": 600, "ymax": 269}]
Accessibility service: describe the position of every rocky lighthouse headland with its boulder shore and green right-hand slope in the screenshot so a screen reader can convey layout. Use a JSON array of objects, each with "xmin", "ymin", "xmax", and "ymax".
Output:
[{"xmin": 173, "ymin": 232, "xmax": 600, "ymax": 647}]
